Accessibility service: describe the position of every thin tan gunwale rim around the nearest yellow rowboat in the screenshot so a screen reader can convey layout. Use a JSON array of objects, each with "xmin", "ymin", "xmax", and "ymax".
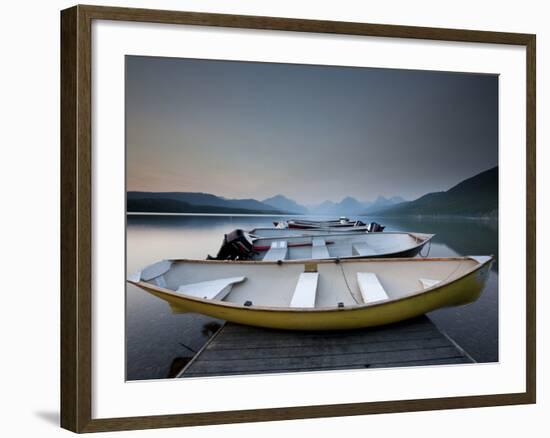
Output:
[{"xmin": 126, "ymin": 255, "xmax": 494, "ymax": 313}]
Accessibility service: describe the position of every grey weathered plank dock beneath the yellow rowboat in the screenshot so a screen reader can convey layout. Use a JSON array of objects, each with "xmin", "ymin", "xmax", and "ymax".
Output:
[{"xmin": 178, "ymin": 316, "xmax": 474, "ymax": 378}]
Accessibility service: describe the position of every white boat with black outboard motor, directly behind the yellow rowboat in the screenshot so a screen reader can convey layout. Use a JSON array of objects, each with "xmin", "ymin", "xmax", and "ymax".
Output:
[{"xmin": 209, "ymin": 230, "xmax": 434, "ymax": 261}]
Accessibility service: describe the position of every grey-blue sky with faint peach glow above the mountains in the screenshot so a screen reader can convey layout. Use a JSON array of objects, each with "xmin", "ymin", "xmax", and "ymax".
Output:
[{"xmin": 125, "ymin": 56, "xmax": 498, "ymax": 205}]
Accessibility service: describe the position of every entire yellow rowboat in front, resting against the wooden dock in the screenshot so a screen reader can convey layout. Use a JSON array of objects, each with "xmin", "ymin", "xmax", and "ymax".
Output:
[{"xmin": 128, "ymin": 256, "xmax": 493, "ymax": 330}]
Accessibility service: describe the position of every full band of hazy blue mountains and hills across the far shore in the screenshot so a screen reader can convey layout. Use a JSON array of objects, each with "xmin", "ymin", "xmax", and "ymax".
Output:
[{"xmin": 127, "ymin": 167, "xmax": 498, "ymax": 217}]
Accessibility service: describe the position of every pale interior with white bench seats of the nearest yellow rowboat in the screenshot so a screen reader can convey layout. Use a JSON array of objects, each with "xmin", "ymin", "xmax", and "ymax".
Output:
[{"xmin": 141, "ymin": 257, "xmax": 488, "ymax": 309}]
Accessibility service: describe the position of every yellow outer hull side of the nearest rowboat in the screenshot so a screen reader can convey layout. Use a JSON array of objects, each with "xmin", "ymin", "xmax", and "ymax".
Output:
[{"xmin": 134, "ymin": 260, "xmax": 491, "ymax": 330}]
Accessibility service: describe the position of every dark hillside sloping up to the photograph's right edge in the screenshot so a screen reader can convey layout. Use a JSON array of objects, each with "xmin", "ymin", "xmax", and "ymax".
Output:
[{"xmin": 364, "ymin": 166, "xmax": 498, "ymax": 217}]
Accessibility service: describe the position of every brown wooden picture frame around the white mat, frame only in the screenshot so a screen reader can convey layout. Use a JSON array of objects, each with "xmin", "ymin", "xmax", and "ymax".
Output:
[{"xmin": 61, "ymin": 6, "xmax": 536, "ymax": 432}]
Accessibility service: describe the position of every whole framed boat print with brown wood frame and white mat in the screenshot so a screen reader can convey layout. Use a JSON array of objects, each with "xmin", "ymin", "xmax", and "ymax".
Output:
[{"xmin": 61, "ymin": 6, "xmax": 536, "ymax": 432}]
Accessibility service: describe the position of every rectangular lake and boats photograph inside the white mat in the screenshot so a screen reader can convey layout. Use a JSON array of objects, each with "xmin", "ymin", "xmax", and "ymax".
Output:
[{"xmin": 124, "ymin": 55, "xmax": 500, "ymax": 381}]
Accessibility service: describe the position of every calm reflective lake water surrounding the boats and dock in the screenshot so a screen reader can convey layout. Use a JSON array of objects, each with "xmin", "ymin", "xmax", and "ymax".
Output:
[{"xmin": 126, "ymin": 215, "xmax": 498, "ymax": 380}]
